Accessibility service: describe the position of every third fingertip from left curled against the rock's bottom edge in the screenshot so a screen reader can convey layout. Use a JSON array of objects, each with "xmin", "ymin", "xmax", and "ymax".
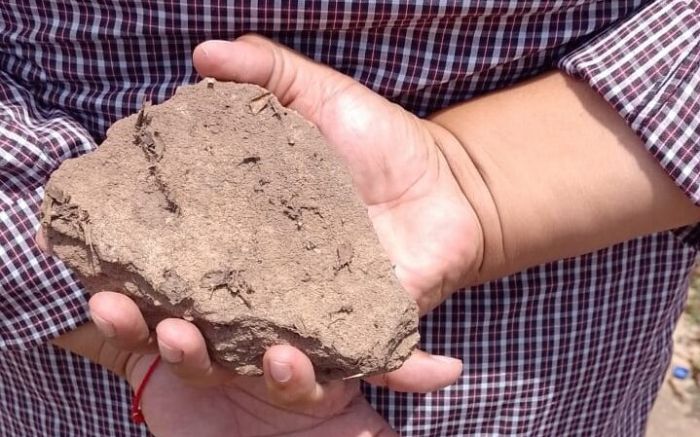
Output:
[{"xmin": 263, "ymin": 345, "xmax": 357, "ymax": 413}]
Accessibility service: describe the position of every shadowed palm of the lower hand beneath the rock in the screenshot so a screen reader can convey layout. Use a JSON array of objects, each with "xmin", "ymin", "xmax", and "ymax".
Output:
[{"xmin": 129, "ymin": 356, "xmax": 393, "ymax": 437}]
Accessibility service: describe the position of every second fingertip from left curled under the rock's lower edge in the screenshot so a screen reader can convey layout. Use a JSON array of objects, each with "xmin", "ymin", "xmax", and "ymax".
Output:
[{"xmin": 156, "ymin": 319, "xmax": 235, "ymax": 387}]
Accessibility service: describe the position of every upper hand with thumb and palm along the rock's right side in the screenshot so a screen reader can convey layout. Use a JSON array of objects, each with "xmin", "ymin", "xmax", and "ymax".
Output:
[{"xmin": 194, "ymin": 36, "xmax": 483, "ymax": 313}]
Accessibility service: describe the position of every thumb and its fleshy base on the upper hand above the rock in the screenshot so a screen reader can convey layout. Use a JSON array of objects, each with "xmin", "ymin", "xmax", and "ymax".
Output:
[{"xmin": 193, "ymin": 35, "xmax": 434, "ymax": 206}]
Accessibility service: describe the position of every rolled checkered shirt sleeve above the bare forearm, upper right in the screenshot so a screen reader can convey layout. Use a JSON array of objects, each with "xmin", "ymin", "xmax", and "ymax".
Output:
[{"xmin": 560, "ymin": 0, "xmax": 700, "ymax": 204}]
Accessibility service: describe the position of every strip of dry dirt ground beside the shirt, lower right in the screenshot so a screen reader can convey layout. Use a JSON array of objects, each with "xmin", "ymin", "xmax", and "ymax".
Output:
[{"xmin": 647, "ymin": 268, "xmax": 700, "ymax": 437}]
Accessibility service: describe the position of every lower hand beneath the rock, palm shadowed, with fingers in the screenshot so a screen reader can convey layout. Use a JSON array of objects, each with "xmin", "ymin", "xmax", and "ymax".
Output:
[{"xmin": 83, "ymin": 292, "xmax": 462, "ymax": 437}]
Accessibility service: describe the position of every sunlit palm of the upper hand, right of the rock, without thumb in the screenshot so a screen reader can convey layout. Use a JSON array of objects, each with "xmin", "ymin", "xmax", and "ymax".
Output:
[{"xmin": 318, "ymin": 96, "xmax": 479, "ymax": 312}]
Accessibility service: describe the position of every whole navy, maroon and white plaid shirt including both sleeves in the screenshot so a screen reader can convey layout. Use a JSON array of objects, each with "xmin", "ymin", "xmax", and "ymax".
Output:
[{"xmin": 0, "ymin": 0, "xmax": 700, "ymax": 436}]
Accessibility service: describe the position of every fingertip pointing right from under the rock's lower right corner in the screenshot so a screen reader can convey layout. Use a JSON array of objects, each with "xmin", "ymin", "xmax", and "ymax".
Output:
[{"xmin": 365, "ymin": 350, "xmax": 462, "ymax": 393}]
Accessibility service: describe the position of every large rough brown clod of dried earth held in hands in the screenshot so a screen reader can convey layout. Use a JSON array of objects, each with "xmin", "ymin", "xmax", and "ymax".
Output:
[{"xmin": 43, "ymin": 81, "xmax": 418, "ymax": 380}]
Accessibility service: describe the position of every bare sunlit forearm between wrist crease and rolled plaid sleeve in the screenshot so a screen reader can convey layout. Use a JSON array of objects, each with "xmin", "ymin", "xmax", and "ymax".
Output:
[{"xmin": 432, "ymin": 73, "xmax": 700, "ymax": 282}]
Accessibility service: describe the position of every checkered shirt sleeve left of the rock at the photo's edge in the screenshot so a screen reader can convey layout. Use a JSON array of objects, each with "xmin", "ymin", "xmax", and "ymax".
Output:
[{"xmin": 0, "ymin": 71, "xmax": 95, "ymax": 353}]
